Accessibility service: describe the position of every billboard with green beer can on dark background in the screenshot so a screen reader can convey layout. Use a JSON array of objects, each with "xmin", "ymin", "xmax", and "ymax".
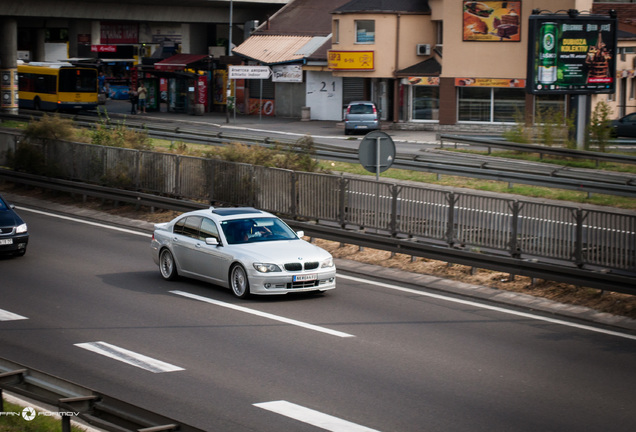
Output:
[{"xmin": 526, "ymin": 15, "xmax": 617, "ymax": 94}]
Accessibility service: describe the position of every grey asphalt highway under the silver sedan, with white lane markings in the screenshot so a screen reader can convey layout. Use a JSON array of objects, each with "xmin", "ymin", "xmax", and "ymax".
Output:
[{"xmin": 0, "ymin": 205, "xmax": 636, "ymax": 432}]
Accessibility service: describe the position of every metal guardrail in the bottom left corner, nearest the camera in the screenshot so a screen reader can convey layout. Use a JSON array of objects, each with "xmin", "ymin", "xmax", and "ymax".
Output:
[{"xmin": 0, "ymin": 358, "xmax": 204, "ymax": 432}]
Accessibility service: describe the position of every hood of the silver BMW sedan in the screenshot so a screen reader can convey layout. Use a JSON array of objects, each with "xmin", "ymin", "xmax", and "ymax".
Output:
[{"xmin": 234, "ymin": 239, "xmax": 331, "ymax": 264}]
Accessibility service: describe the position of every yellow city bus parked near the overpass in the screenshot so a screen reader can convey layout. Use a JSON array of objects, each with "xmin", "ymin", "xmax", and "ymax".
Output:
[{"xmin": 18, "ymin": 62, "xmax": 97, "ymax": 111}]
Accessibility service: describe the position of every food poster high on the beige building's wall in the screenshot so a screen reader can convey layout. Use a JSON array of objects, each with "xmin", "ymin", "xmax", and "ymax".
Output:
[{"xmin": 462, "ymin": 0, "xmax": 521, "ymax": 42}]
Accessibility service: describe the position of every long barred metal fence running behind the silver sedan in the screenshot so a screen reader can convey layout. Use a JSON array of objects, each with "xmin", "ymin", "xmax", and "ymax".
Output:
[{"xmin": 0, "ymin": 137, "xmax": 636, "ymax": 272}]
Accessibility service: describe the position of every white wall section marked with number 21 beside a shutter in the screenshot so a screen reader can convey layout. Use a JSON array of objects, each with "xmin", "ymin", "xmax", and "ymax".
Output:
[{"xmin": 305, "ymin": 71, "xmax": 342, "ymax": 121}]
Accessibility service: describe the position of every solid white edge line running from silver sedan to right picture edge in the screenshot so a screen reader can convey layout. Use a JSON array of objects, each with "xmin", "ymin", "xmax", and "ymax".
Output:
[{"xmin": 338, "ymin": 274, "xmax": 636, "ymax": 340}]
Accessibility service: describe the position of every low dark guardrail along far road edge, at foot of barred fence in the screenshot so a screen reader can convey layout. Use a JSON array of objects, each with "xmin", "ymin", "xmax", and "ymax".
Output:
[{"xmin": 0, "ymin": 170, "xmax": 636, "ymax": 295}]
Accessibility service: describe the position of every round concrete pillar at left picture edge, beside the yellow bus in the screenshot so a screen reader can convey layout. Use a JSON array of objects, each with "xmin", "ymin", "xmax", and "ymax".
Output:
[{"xmin": 0, "ymin": 17, "xmax": 18, "ymax": 114}]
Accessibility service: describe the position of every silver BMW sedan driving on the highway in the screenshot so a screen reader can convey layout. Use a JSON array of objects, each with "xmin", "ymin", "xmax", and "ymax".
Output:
[{"xmin": 150, "ymin": 207, "xmax": 336, "ymax": 298}]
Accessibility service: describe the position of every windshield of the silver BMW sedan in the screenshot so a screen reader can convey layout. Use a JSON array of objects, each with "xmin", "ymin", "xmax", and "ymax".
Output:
[{"xmin": 221, "ymin": 218, "xmax": 298, "ymax": 244}]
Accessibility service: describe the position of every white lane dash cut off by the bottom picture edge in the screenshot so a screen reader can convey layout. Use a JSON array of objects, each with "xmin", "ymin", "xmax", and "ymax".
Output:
[{"xmin": 254, "ymin": 401, "xmax": 378, "ymax": 432}]
